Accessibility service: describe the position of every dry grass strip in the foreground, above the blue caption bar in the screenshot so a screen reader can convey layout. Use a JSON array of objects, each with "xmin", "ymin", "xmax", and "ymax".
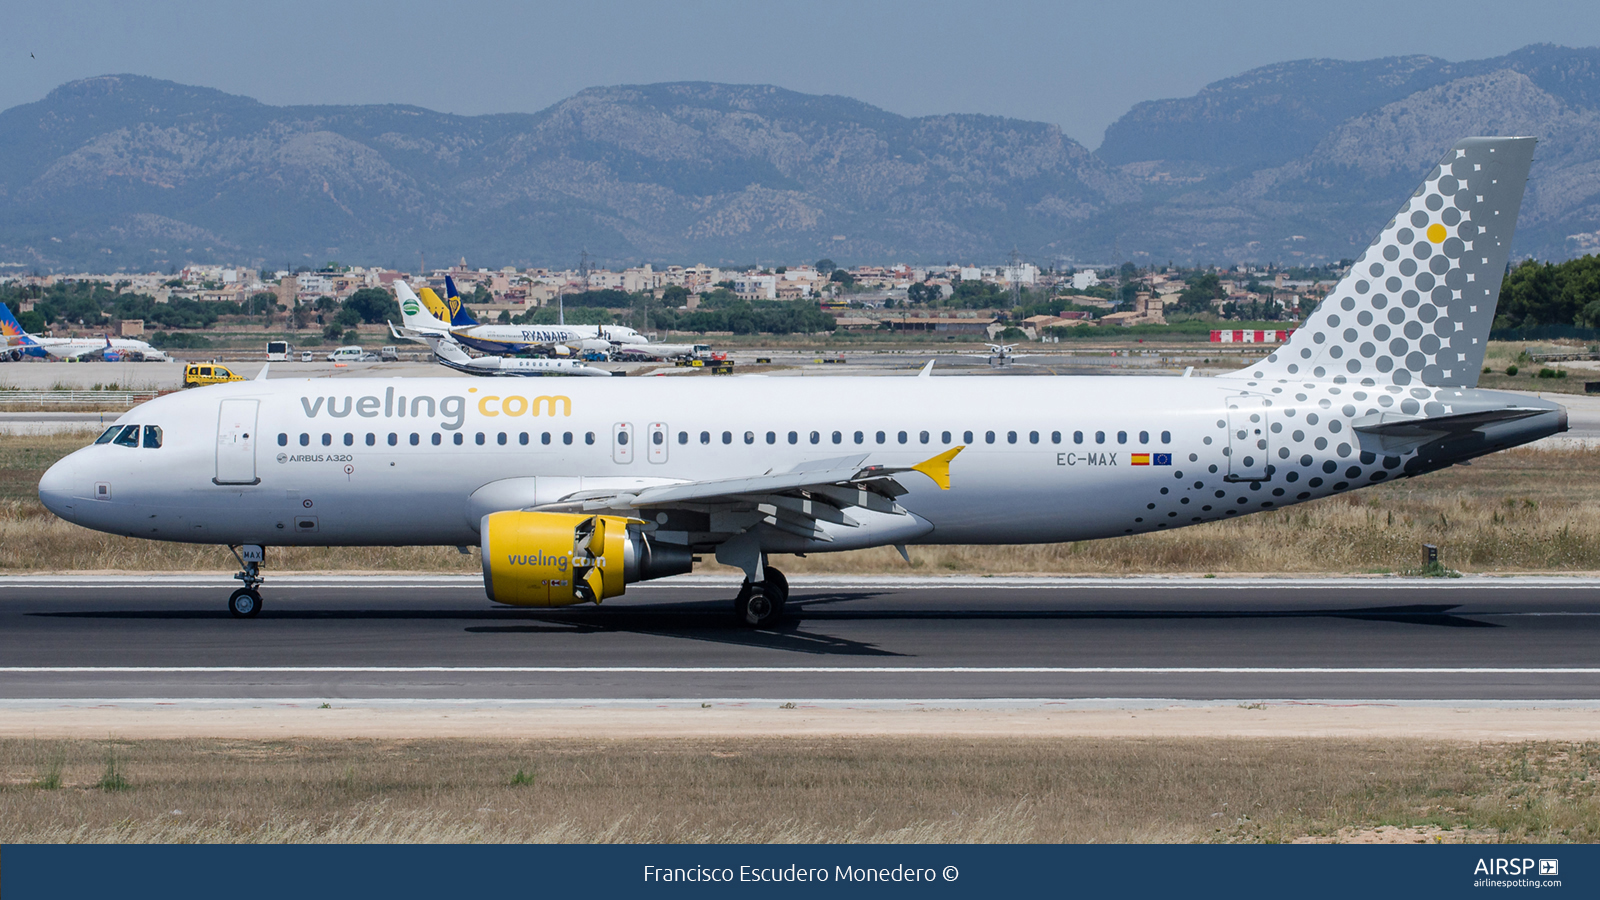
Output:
[{"xmin": 0, "ymin": 738, "xmax": 1600, "ymax": 842}]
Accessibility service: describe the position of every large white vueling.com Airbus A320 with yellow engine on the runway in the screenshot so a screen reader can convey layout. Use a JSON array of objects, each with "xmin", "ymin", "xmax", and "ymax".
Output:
[{"xmin": 38, "ymin": 138, "xmax": 1566, "ymax": 626}]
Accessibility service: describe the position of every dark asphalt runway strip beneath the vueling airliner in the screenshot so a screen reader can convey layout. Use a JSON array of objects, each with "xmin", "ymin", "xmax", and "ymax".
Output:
[{"xmin": 0, "ymin": 575, "xmax": 1600, "ymax": 705}]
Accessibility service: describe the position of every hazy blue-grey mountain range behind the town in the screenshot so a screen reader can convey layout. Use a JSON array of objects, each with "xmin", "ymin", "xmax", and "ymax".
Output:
[{"xmin": 0, "ymin": 45, "xmax": 1600, "ymax": 272}]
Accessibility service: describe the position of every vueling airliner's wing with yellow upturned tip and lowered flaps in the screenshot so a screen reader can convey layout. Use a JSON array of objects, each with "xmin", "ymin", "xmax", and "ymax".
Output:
[{"xmin": 538, "ymin": 445, "xmax": 965, "ymax": 541}]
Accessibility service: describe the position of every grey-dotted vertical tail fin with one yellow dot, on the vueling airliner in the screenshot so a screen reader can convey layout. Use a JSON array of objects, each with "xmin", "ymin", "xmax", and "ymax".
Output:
[{"xmin": 1229, "ymin": 138, "xmax": 1534, "ymax": 388}]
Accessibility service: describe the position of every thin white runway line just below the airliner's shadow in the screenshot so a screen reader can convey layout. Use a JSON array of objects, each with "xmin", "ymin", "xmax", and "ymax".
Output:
[{"xmin": 9, "ymin": 666, "xmax": 1600, "ymax": 674}]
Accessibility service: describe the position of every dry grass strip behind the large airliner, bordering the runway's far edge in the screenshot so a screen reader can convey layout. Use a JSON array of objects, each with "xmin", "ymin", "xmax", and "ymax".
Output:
[{"xmin": 0, "ymin": 434, "xmax": 1600, "ymax": 575}]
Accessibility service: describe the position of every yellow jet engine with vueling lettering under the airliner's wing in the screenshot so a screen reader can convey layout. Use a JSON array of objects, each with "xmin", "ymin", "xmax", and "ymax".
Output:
[{"xmin": 478, "ymin": 509, "xmax": 694, "ymax": 607}]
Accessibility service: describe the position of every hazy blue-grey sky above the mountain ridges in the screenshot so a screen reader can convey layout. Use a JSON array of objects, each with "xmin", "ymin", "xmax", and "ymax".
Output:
[{"xmin": 9, "ymin": 0, "xmax": 1600, "ymax": 147}]
